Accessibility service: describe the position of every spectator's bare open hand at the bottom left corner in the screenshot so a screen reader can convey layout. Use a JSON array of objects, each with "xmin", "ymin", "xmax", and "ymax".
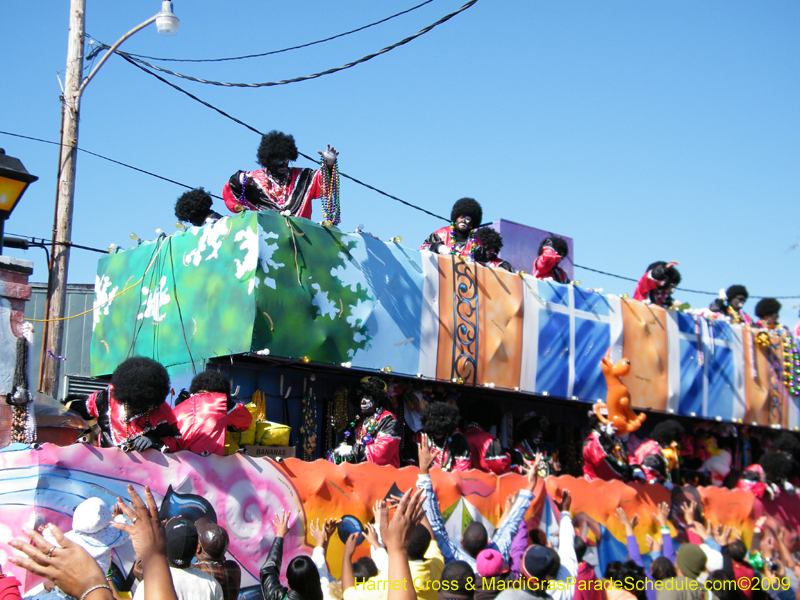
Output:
[{"xmin": 8, "ymin": 525, "xmax": 111, "ymax": 600}]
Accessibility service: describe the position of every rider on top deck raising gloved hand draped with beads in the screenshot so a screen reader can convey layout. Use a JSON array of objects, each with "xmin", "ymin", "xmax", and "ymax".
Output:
[{"xmin": 222, "ymin": 131, "xmax": 340, "ymax": 226}]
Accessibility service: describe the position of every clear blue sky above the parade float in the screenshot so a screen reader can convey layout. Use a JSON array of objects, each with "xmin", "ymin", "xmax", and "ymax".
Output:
[{"xmin": 0, "ymin": 0, "xmax": 800, "ymax": 325}]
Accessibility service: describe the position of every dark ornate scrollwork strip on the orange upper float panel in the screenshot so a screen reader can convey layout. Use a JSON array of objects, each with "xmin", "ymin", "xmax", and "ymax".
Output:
[{"xmin": 450, "ymin": 259, "xmax": 478, "ymax": 385}]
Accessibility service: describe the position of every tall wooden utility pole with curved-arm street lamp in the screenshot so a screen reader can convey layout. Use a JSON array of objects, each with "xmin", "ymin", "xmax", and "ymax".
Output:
[{"xmin": 39, "ymin": 0, "xmax": 179, "ymax": 397}]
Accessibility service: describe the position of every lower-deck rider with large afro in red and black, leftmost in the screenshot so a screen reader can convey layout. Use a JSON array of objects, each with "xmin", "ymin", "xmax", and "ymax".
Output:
[{"xmin": 67, "ymin": 356, "xmax": 180, "ymax": 452}]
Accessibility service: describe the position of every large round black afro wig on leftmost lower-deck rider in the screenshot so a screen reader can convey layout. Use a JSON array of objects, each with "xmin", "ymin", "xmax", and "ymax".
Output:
[{"xmin": 111, "ymin": 356, "xmax": 169, "ymax": 415}]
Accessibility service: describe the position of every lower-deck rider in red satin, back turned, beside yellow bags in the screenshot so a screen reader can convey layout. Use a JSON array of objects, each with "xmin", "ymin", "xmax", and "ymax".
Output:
[{"xmin": 162, "ymin": 371, "xmax": 253, "ymax": 456}]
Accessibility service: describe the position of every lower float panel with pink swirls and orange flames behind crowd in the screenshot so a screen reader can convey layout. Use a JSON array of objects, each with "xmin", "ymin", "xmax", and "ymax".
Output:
[{"xmin": 0, "ymin": 444, "xmax": 800, "ymax": 597}]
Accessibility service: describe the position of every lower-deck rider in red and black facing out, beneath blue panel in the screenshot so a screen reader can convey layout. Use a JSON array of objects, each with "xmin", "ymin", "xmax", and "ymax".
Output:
[{"xmin": 334, "ymin": 377, "xmax": 402, "ymax": 469}]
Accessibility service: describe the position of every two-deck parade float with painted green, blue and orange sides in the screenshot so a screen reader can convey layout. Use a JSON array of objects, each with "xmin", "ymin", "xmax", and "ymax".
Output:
[{"xmin": 0, "ymin": 212, "xmax": 800, "ymax": 595}]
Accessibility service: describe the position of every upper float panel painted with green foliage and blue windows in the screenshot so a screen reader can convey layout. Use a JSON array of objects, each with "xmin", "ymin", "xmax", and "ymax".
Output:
[{"xmin": 92, "ymin": 212, "xmax": 798, "ymax": 428}]
